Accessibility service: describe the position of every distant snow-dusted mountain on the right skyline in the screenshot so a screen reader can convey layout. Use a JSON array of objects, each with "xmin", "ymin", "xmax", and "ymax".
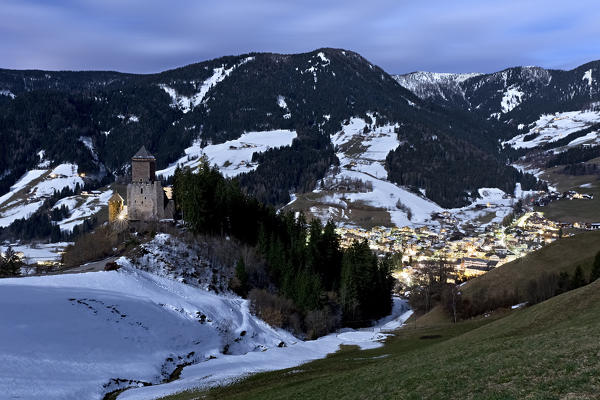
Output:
[{"xmin": 394, "ymin": 61, "xmax": 600, "ymax": 128}]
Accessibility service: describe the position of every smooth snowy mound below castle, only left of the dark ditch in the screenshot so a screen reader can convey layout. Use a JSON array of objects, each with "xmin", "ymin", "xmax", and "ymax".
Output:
[{"xmin": 0, "ymin": 261, "xmax": 296, "ymax": 400}]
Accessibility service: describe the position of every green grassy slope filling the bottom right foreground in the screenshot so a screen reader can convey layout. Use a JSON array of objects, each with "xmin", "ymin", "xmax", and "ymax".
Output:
[{"xmin": 162, "ymin": 281, "xmax": 600, "ymax": 399}]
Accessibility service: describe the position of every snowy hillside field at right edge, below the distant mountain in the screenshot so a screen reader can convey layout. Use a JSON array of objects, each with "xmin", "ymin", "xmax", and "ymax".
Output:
[{"xmin": 504, "ymin": 110, "xmax": 600, "ymax": 149}]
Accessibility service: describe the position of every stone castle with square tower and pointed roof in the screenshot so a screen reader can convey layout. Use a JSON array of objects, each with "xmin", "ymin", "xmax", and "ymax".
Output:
[{"xmin": 127, "ymin": 146, "xmax": 165, "ymax": 221}]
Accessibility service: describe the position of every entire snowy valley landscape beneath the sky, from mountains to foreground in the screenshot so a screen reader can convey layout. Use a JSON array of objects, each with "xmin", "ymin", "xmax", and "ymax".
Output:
[{"xmin": 0, "ymin": 48, "xmax": 600, "ymax": 399}]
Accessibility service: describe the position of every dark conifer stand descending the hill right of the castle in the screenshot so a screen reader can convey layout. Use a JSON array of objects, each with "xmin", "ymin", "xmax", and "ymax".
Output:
[{"xmin": 173, "ymin": 160, "xmax": 392, "ymax": 337}]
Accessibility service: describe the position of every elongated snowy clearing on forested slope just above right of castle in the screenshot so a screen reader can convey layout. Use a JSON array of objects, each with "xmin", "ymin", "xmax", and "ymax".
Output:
[{"xmin": 156, "ymin": 129, "xmax": 297, "ymax": 178}]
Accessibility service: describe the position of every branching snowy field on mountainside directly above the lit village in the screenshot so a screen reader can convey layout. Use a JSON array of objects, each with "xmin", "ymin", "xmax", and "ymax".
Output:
[{"xmin": 292, "ymin": 114, "xmax": 530, "ymax": 229}]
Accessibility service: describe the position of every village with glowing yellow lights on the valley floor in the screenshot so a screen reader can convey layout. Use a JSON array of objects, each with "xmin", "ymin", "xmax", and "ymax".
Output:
[{"xmin": 337, "ymin": 210, "xmax": 580, "ymax": 285}]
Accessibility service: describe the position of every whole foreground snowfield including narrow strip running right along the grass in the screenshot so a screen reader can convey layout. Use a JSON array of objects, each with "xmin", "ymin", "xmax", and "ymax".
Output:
[{"xmin": 0, "ymin": 247, "xmax": 410, "ymax": 400}]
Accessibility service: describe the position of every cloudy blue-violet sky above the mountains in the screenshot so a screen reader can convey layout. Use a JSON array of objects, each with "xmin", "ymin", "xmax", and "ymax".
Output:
[{"xmin": 0, "ymin": 0, "xmax": 600, "ymax": 73}]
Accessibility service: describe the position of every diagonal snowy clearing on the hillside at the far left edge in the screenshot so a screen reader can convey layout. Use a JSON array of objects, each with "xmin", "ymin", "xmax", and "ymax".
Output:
[{"xmin": 0, "ymin": 164, "xmax": 83, "ymax": 227}]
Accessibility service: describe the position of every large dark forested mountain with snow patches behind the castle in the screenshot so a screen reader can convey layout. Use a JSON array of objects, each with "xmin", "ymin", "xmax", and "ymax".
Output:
[{"xmin": 0, "ymin": 48, "xmax": 536, "ymax": 238}]
